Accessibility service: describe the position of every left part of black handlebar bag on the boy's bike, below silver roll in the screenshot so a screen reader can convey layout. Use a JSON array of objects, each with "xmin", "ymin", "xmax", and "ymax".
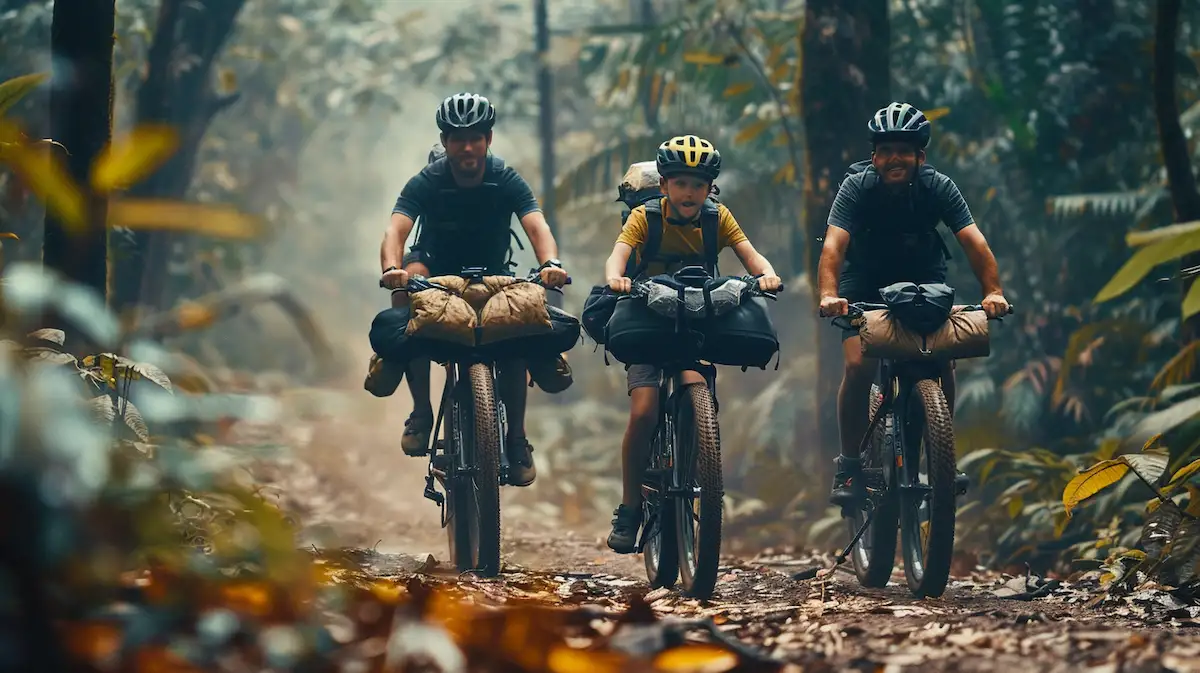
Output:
[{"xmin": 605, "ymin": 296, "xmax": 704, "ymax": 366}]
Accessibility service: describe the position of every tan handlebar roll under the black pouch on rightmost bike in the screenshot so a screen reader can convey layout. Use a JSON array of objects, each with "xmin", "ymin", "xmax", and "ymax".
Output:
[{"xmin": 858, "ymin": 307, "xmax": 991, "ymax": 360}]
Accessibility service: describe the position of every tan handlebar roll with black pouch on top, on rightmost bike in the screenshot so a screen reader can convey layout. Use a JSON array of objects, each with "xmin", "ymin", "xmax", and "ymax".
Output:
[{"xmin": 858, "ymin": 283, "xmax": 991, "ymax": 360}]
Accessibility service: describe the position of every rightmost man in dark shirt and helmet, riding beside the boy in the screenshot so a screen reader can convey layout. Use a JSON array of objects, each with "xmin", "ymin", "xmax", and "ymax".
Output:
[{"xmin": 817, "ymin": 102, "xmax": 1008, "ymax": 505}]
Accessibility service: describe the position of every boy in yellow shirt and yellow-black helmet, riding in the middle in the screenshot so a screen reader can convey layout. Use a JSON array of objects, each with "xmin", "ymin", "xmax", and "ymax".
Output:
[{"xmin": 605, "ymin": 136, "xmax": 781, "ymax": 554}]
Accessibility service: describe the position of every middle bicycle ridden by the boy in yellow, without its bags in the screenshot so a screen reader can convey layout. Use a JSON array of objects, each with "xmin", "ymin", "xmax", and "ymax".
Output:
[{"xmin": 629, "ymin": 269, "xmax": 782, "ymax": 599}]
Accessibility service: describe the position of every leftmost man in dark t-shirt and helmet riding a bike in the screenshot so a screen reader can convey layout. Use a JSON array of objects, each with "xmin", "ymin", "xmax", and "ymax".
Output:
[{"xmin": 379, "ymin": 94, "xmax": 570, "ymax": 486}]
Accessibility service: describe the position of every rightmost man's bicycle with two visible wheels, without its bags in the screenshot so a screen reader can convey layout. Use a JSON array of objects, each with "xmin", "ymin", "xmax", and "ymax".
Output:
[{"xmin": 816, "ymin": 296, "xmax": 1013, "ymax": 597}]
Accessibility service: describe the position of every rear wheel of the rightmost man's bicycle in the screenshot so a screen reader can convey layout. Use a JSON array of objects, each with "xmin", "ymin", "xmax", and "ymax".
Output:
[{"xmin": 846, "ymin": 384, "xmax": 900, "ymax": 588}]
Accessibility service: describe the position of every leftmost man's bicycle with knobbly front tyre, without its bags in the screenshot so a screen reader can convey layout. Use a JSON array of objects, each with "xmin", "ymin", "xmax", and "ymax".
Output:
[{"xmin": 380, "ymin": 268, "xmax": 571, "ymax": 577}]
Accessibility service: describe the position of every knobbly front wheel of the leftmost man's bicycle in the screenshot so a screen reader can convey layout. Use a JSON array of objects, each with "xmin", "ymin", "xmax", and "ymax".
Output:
[{"xmin": 450, "ymin": 363, "xmax": 500, "ymax": 577}]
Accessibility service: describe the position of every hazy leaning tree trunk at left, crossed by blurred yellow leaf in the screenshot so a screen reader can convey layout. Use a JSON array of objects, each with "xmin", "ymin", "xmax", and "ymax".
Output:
[{"xmin": 113, "ymin": 0, "xmax": 245, "ymax": 311}]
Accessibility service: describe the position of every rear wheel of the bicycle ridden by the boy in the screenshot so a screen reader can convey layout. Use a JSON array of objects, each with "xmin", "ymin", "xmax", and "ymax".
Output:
[{"xmin": 642, "ymin": 425, "xmax": 679, "ymax": 589}]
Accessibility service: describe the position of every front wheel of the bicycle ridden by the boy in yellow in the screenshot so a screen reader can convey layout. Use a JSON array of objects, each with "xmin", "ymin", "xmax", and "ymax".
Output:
[{"xmin": 673, "ymin": 384, "xmax": 725, "ymax": 599}]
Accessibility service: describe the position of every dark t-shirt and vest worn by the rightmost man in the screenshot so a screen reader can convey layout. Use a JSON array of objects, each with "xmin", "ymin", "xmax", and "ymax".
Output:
[{"xmin": 829, "ymin": 166, "xmax": 974, "ymax": 296}]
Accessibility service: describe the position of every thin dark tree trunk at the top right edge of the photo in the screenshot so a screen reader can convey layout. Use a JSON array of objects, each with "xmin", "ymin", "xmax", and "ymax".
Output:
[{"xmin": 1154, "ymin": 0, "xmax": 1200, "ymax": 344}]
